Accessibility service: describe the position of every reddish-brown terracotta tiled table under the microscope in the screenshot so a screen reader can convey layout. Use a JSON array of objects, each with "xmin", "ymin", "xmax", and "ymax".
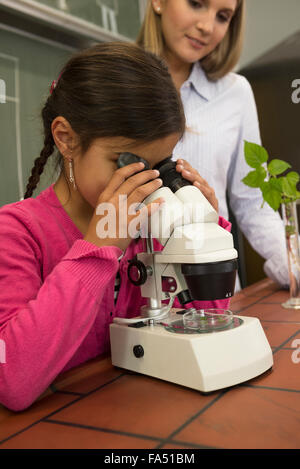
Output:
[{"xmin": 0, "ymin": 279, "xmax": 300, "ymax": 449}]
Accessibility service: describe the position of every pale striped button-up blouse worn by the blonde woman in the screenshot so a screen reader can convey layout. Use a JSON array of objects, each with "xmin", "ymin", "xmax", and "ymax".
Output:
[{"xmin": 174, "ymin": 63, "xmax": 289, "ymax": 285}]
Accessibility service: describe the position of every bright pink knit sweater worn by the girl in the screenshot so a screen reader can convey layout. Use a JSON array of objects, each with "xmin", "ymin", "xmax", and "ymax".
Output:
[{"xmin": 0, "ymin": 186, "xmax": 230, "ymax": 411}]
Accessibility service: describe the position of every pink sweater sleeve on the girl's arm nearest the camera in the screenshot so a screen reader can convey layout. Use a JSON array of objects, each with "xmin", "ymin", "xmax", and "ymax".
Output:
[{"xmin": 0, "ymin": 188, "xmax": 122, "ymax": 411}]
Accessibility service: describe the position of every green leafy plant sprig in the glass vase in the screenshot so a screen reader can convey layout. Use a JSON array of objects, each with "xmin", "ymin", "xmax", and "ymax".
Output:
[{"xmin": 242, "ymin": 140, "xmax": 300, "ymax": 211}]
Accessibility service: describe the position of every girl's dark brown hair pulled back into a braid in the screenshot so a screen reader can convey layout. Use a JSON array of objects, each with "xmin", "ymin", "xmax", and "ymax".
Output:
[{"xmin": 24, "ymin": 42, "xmax": 185, "ymax": 198}]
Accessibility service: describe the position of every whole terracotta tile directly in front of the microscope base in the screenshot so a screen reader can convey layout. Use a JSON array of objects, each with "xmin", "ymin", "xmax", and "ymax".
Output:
[{"xmin": 53, "ymin": 374, "xmax": 218, "ymax": 438}]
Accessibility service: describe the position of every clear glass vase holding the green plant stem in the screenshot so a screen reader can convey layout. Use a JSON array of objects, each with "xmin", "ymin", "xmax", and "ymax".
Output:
[{"xmin": 282, "ymin": 201, "xmax": 300, "ymax": 309}]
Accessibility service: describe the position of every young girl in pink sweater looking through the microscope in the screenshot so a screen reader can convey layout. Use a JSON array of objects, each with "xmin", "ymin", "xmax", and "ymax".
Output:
[{"xmin": 0, "ymin": 43, "xmax": 229, "ymax": 411}]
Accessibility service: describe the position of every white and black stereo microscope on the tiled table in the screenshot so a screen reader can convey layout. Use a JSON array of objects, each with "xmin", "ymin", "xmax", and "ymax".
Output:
[{"xmin": 110, "ymin": 153, "xmax": 273, "ymax": 393}]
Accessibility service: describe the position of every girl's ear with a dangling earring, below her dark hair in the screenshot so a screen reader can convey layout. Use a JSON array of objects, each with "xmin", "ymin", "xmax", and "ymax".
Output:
[{"xmin": 51, "ymin": 116, "xmax": 78, "ymax": 157}]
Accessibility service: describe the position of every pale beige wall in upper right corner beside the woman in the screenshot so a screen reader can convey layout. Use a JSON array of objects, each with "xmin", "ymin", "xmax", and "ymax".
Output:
[{"xmin": 239, "ymin": 0, "xmax": 300, "ymax": 68}]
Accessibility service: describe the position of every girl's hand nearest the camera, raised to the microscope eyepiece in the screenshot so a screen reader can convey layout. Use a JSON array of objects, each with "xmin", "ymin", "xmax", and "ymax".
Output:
[{"xmin": 84, "ymin": 163, "xmax": 164, "ymax": 250}]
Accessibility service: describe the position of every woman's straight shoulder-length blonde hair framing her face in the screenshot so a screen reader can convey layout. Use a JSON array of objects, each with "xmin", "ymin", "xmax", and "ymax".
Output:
[{"xmin": 136, "ymin": 0, "xmax": 245, "ymax": 80}]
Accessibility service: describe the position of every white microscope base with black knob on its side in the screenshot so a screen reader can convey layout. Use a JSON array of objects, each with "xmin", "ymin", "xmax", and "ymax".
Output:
[{"xmin": 110, "ymin": 313, "xmax": 273, "ymax": 392}]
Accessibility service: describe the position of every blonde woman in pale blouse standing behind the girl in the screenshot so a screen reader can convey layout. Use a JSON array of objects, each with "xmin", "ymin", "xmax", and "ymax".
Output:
[{"xmin": 137, "ymin": 0, "xmax": 289, "ymax": 286}]
